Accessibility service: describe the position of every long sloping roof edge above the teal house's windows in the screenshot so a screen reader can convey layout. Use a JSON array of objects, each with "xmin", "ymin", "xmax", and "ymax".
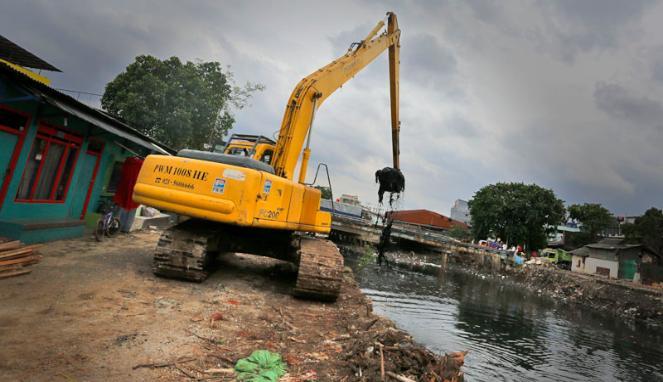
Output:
[{"xmin": 0, "ymin": 62, "xmax": 175, "ymax": 154}]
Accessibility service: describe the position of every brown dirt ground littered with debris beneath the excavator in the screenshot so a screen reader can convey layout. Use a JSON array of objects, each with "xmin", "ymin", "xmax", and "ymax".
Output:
[{"xmin": 0, "ymin": 231, "xmax": 462, "ymax": 381}]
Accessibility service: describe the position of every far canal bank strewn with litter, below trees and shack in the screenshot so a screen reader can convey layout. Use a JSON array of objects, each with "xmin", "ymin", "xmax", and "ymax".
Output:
[{"xmin": 387, "ymin": 252, "xmax": 663, "ymax": 327}]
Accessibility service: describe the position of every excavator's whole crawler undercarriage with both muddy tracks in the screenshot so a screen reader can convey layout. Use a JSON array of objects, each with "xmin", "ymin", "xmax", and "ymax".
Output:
[{"xmin": 153, "ymin": 219, "xmax": 343, "ymax": 301}]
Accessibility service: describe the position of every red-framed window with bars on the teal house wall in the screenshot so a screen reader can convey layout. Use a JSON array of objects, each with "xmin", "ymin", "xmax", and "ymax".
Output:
[{"xmin": 16, "ymin": 126, "xmax": 82, "ymax": 203}]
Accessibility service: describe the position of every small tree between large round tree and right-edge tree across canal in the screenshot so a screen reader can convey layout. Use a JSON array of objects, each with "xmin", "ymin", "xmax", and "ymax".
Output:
[{"xmin": 569, "ymin": 203, "xmax": 615, "ymax": 247}]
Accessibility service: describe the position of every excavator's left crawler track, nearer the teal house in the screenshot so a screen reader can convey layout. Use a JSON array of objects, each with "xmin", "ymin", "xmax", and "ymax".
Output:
[{"xmin": 152, "ymin": 224, "xmax": 213, "ymax": 282}]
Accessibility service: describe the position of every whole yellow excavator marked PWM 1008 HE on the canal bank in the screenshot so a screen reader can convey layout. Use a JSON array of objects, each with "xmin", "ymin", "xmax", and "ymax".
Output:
[{"xmin": 133, "ymin": 12, "xmax": 400, "ymax": 300}]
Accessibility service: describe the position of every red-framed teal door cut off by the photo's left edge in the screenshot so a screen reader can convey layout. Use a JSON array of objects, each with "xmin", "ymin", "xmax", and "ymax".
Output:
[{"xmin": 0, "ymin": 106, "xmax": 29, "ymax": 208}]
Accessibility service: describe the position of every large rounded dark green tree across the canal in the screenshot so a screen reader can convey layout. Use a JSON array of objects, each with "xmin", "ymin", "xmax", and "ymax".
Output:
[{"xmin": 469, "ymin": 183, "xmax": 565, "ymax": 249}]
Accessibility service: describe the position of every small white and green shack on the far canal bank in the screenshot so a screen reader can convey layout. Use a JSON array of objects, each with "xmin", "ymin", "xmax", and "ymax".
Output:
[{"xmin": 571, "ymin": 238, "xmax": 659, "ymax": 281}]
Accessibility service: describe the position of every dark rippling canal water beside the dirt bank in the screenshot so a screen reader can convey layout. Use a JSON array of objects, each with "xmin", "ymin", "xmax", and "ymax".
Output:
[{"xmin": 348, "ymin": 259, "xmax": 663, "ymax": 382}]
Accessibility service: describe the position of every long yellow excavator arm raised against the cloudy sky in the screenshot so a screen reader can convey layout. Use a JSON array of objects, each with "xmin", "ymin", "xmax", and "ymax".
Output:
[{"xmin": 272, "ymin": 12, "xmax": 401, "ymax": 183}]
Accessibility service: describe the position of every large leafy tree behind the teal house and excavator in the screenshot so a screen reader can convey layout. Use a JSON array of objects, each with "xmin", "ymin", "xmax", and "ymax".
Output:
[{"xmin": 101, "ymin": 55, "xmax": 264, "ymax": 149}]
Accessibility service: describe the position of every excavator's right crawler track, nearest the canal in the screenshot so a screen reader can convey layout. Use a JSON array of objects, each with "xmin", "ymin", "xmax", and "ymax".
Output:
[{"xmin": 294, "ymin": 237, "xmax": 343, "ymax": 301}]
